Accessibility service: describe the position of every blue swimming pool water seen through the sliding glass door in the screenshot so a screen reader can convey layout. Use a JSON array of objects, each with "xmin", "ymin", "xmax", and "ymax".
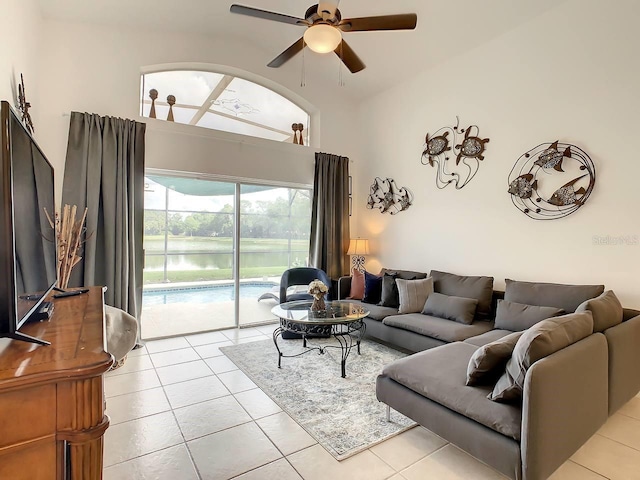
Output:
[{"xmin": 142, "ymin": 282, "xmax": 278, "ymax": 306}]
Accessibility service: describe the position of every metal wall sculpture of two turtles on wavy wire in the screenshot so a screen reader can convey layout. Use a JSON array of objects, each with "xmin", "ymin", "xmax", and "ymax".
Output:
[{"xmin": 421, "ymin": 117, "xmax": 489, "ymax": 190}]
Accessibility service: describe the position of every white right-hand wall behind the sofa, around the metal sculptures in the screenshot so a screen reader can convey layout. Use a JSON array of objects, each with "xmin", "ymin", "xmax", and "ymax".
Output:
[{"xmin": 352, "ymin": 0, "xmax": 640, "ymax": 307}]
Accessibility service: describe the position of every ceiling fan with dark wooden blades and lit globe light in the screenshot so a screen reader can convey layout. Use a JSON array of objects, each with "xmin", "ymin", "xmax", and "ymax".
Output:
[{"xmin": 231, "ymin": 0, "xmax": 418, "ymax": 73}]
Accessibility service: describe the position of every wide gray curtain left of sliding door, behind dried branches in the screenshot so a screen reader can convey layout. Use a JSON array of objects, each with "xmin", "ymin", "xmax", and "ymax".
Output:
[{"xmin": 62, "ymin": 112, "xmax": 146, "ymax": 318}]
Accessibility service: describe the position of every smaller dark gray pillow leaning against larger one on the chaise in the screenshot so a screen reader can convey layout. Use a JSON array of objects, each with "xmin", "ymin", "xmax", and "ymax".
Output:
[{"xmin": 467, "ymin": 332, "xmax": 522, "ymax": 386}]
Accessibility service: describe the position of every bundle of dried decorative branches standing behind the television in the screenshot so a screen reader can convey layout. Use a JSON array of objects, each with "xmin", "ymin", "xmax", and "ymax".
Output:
[{"xmin": 45, "ymin": 205, "xmax": 87, "ymax": 289}]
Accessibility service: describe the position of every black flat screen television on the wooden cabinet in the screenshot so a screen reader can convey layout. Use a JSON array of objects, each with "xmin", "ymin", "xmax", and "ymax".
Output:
[{"xmin": 0, "ymin": 101, "xmax": 57, "ymax": 344}]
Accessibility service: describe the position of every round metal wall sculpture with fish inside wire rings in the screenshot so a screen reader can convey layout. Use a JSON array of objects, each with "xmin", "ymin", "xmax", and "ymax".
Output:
[{"xmin": 508, "ymin": 140, "xmax": 596, "ymax": 220}]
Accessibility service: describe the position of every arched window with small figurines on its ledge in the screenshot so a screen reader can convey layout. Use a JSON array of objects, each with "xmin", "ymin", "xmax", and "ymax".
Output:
[{"xmin": 140, "ymin": 70, "xmax": 310, "ymax": 145}]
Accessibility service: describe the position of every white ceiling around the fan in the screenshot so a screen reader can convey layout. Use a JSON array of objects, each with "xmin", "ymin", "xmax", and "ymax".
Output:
[{"xmin": 37, "ymin": 0, "xmax": 565, "ymax": 98}]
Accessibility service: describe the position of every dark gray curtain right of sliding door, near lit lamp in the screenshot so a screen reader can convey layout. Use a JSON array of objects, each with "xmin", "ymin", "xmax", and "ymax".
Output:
[{"xmin": 309, "ymin": 153, "xmax": 349, "ymax": 280}]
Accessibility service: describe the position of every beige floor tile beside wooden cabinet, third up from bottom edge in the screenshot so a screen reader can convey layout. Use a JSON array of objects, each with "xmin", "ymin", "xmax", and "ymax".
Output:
[{"xmin": 107, "ymin": 387, "xmax": 171, "ymax": 425}]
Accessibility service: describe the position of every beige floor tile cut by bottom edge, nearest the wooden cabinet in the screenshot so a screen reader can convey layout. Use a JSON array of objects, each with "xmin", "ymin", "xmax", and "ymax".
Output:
[{"xmin": 103, "ymin": 444, "xmax": 199, "ymax": 480}]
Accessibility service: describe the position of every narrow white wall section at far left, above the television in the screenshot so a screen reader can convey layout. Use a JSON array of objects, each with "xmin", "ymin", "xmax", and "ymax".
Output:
[{"xmin": 0, "ymin": 0, "xmax": 41, "ymax": 129}]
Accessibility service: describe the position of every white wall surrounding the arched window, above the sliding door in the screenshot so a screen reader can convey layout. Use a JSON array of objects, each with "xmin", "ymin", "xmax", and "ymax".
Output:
[{"xmin": 40, "ymin": 20, "xmax": 358, "ymax": 200}]
